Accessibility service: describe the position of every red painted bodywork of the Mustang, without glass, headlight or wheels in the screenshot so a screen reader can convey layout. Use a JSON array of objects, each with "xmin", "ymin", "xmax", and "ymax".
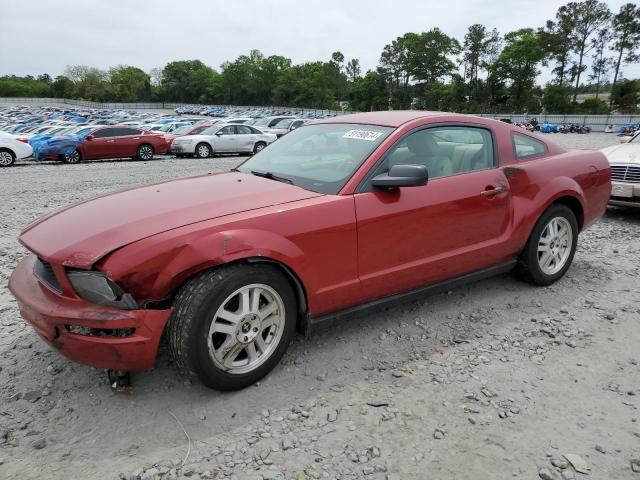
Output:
[{"xmin": 10, "ymin": 112, "xmax": 611, "ymax": 370}]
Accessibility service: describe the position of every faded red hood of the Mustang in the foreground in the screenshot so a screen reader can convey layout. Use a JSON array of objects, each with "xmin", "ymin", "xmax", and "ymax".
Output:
[{"xmin": 20, "ymin": 172, "xmax": 322, "ymax": 268}]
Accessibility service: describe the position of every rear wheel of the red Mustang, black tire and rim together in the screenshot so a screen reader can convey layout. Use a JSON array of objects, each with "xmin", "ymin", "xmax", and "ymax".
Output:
[{"xmin": 517, "ymin": 204, "xmax": 579, "ymax": 286}]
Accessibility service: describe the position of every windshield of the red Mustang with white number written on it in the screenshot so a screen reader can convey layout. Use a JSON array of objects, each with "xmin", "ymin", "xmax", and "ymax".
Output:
[{"xmin": 238, "ymin": 123, "xmax": 393, "ymax": 195}]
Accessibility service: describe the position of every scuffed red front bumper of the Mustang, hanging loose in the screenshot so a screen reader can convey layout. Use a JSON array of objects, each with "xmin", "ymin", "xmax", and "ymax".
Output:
[{"xmin": 9, "ymin": 255, "xmax": 171, "ymax": 371}]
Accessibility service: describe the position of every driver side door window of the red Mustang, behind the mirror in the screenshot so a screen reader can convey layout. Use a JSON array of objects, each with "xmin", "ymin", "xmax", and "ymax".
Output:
[{"xmin": 385, "ymin": 127, "xmax": 494, "ymax": 179}]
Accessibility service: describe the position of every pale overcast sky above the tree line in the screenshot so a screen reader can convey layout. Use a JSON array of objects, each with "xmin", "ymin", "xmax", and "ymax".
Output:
[{"xmin": 0, "ymin": 0, "xmax": 640, "ymax": 83}]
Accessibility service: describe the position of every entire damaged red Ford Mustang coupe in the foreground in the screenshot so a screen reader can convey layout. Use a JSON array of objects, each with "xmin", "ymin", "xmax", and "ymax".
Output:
[{"xmin": 9, "ymin": 111, "xmax": 611, "ymax": 390}]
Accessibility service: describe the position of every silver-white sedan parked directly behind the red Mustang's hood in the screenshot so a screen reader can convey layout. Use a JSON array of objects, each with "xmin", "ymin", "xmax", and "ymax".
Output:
[{"xmin": 171, "ymin": 124, "xmax": 277, "ymax": 158}]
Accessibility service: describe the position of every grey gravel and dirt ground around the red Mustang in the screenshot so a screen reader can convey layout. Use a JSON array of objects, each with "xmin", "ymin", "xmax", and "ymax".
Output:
[{"xmin": 0, "ymin": 134, "xmax": 640, "ymax": 480}]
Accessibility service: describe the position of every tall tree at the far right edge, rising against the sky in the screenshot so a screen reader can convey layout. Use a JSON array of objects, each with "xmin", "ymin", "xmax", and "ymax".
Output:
[{"xmin": 611, "ymin": 3, "xmax": 640, "ymax": 94}]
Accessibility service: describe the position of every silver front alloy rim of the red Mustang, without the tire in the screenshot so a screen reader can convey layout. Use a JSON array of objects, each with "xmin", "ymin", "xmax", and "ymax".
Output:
[{"xmin": 207, "ymin": 284, "xmax": 285, "ymax": 374}]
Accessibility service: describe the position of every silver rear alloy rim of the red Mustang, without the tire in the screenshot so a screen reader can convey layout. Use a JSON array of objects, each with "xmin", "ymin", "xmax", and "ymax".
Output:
[{"xmin": 538, "ymin": 217, "xmax": 573, "ymax": 275}]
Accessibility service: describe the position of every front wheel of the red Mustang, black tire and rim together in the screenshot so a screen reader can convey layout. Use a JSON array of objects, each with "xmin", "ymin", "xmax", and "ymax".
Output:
[{"xmin": 167, "ymin": 264, "xmax": 297, "ymax": 391}]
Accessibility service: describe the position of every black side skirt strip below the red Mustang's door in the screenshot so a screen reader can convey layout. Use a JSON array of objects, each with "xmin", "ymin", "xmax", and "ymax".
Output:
[{"xmin": 303, "ymin": 260, "xmax": 517, "ymax": 336}]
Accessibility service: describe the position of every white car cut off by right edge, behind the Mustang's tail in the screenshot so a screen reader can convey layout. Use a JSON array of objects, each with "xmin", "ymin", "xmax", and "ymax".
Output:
[{"xmin": 601, "ymin": 131, "xmax": 640, "ymax": 208}]
